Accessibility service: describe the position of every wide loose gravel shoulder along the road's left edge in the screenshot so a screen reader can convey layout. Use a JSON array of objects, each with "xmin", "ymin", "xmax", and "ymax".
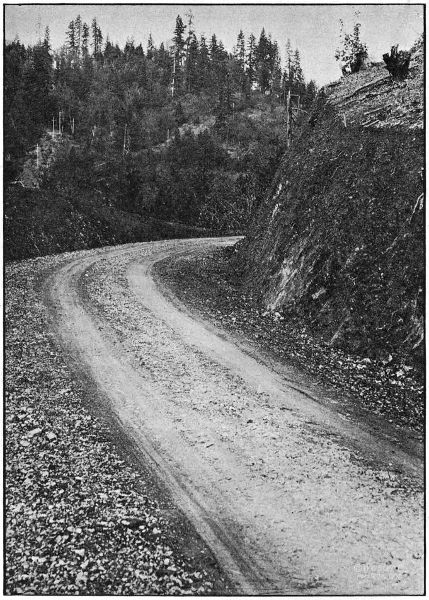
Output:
[{"xmin": 4, "ymin": 255, "xmax": 227, "ymax": 595}]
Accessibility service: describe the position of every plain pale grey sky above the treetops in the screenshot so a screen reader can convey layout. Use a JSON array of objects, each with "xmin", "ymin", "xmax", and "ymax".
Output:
[{"xmin": 5, "ymin": 3, "xmax": 424, "ymax": 85}]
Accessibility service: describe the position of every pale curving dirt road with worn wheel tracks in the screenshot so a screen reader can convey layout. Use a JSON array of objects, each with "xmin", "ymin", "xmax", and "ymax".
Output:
[{"xmin": 43, "ymin": 239, "xmax": 423, "ymax": 594}]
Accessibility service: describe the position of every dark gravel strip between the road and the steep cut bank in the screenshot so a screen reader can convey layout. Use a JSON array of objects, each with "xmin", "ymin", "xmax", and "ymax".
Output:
[{"xmin": 156, "ymin": 248, "xmax": 424, "ymax": 441}]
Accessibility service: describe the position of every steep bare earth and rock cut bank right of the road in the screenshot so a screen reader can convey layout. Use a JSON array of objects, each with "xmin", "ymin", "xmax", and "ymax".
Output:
[{"xmin": 235, "ymin": 41, "xmax": 424, "ymax": 365}]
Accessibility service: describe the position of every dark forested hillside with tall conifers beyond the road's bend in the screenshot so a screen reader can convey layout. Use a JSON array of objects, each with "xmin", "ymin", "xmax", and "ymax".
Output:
[{"xmin": 4, "ymin": 15, "xmax": 316, "ymax": 258}]
